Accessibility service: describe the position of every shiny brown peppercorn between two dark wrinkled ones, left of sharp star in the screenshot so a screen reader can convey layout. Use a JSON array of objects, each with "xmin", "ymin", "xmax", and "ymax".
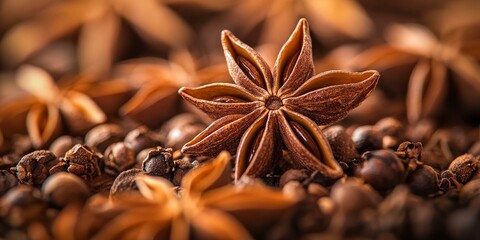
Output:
[{"xmin": 104, "ymin": 142, "xmax": 135, "ymax": 175}]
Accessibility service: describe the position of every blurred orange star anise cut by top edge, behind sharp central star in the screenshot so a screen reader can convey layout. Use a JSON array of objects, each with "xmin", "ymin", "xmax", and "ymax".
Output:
[{"xmin": 208, "ymin": 0, "xmax": 374, "ymax": 46}]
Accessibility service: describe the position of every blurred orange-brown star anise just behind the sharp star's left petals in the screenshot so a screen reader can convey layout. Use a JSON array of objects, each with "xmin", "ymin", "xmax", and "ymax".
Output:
[{"xmin": 115, "ymin": 51, "xmax": 229, "ymax": 129}]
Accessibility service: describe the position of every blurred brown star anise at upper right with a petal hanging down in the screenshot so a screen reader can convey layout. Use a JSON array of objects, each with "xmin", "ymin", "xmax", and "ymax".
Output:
[{"xmin": 352, "ymin": 24, "xmax": 480, "ymax": 123}]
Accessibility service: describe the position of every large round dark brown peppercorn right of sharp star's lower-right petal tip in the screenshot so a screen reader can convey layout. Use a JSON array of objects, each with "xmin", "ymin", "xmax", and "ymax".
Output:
[{"xmin": 355, "ymin": 149, "xmax": 405, "ymax": 191}]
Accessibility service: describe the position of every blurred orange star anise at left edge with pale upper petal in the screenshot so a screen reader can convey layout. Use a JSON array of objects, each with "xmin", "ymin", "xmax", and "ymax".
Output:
[{"xmin": 0, "ymin": 66, "xmax": 106, "ymax": 148}]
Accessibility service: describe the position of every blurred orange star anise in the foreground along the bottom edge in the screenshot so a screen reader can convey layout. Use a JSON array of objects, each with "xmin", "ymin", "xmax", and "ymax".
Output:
[{"xmin": 53, "ymin": 152, "xmax": 297, "ymax": 239}]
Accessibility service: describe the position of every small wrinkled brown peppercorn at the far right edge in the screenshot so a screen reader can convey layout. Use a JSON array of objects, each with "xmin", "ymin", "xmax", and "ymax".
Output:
[{"xmin": 448, "ymin": 154, "xmax": 479, "ymax": 184}]
